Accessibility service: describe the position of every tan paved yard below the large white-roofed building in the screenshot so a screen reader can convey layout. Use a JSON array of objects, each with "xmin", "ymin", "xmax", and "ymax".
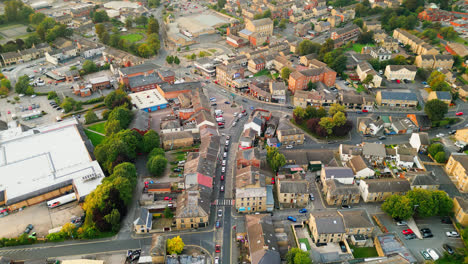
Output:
[{"xmin": 0, "ymin": 202, "xmax": 83, "ymax": 238}]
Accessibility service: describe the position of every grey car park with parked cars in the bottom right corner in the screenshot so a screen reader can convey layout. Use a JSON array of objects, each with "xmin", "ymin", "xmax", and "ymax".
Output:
[{"xmin": 379, "ymin": 215, "xmax": 463, "ymax": 262}]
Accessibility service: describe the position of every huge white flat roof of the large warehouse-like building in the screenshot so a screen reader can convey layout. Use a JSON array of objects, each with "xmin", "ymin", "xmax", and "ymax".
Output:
[{"xmin": 0, "ymin": 119, "xmax": 104, "ymax": 204}]
